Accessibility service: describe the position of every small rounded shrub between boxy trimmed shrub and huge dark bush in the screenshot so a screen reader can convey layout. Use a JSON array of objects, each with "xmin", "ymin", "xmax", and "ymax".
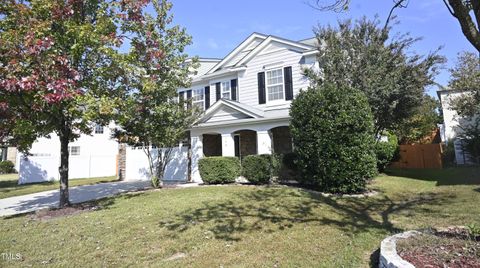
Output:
[{"xmin": 242, "ymin": 154, "xmax": 273, "ymax": 184}]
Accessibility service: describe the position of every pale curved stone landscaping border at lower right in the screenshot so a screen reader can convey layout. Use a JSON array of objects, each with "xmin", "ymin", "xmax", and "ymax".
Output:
[{"xmin": 378, "ymin": 231, "xmax": 421, "ymax": 268}]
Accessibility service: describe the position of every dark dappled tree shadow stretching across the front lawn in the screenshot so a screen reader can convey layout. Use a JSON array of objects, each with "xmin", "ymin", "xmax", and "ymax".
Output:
[{"xmin": 159, "ymin": 187, "xmax": 455, "ymax": 241}]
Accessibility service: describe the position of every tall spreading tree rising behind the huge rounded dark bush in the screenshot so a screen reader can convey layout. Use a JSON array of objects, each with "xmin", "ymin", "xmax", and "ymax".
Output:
[{"xmin": 306, "ymin": 18, "xmax": 444, "ymax": 136}]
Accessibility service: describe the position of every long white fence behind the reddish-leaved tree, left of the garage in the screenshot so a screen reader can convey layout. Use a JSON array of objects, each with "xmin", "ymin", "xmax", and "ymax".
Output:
[{"xmin": 18, "ymin": 154, "xmax": 117, "ymax": 184}]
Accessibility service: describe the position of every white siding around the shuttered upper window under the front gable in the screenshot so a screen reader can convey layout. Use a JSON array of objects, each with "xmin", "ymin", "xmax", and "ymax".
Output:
[{"xmin": 238, "ymin": 49, "xmax": 309, "ymax": 110}]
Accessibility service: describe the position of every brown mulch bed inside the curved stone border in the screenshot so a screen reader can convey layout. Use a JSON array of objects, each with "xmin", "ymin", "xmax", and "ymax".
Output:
[{"xmin": 397, "ymin": 227, "xmax": 480, "ymax": 268}]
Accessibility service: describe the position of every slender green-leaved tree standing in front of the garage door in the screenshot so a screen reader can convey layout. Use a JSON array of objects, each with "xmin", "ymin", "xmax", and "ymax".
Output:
[{"xmin": 116, "ymin": 0, "xmax": 196, "ymax": 187}]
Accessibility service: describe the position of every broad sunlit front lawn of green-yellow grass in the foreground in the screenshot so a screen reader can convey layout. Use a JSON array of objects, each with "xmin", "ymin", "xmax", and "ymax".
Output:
[{"xmin": 0, "ymin": 166, "xmax": 480, "ymax": 267}]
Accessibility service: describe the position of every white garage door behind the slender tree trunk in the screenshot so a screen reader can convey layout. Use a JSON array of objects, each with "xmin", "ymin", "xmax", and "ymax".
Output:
[{"xmin": 125, "ymin": 146, "xmax": 188, "ymax": 181}]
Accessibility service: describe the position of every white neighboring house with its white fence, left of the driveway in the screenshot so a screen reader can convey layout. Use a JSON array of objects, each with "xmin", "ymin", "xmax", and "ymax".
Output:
[{"xmin": 17, "ymin": 124, "xmax": 118, "ymax": 184}]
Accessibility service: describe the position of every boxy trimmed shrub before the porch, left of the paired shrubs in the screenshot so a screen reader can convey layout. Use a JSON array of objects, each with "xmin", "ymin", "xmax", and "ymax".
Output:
[{"xmin": 198, "ymin": 156, "xmax": 240, "ymax": 184}]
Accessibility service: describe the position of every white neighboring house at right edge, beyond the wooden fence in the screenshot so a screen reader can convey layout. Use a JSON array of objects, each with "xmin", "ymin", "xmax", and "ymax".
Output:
[{"xmin": 437, "ymin": 90, "xmax": 474, "ymax": 165}]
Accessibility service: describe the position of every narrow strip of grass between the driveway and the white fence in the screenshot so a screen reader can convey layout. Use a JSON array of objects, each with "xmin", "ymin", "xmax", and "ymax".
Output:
[{"xmin": 0, "ymin": 174, "xmax": 117, "ymax": 199}]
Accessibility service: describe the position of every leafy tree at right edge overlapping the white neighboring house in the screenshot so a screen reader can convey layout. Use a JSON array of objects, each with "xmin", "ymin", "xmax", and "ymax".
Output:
[{"xmin": 448, "ymin": 52, "xmax": 480, "ymax": 117}]
